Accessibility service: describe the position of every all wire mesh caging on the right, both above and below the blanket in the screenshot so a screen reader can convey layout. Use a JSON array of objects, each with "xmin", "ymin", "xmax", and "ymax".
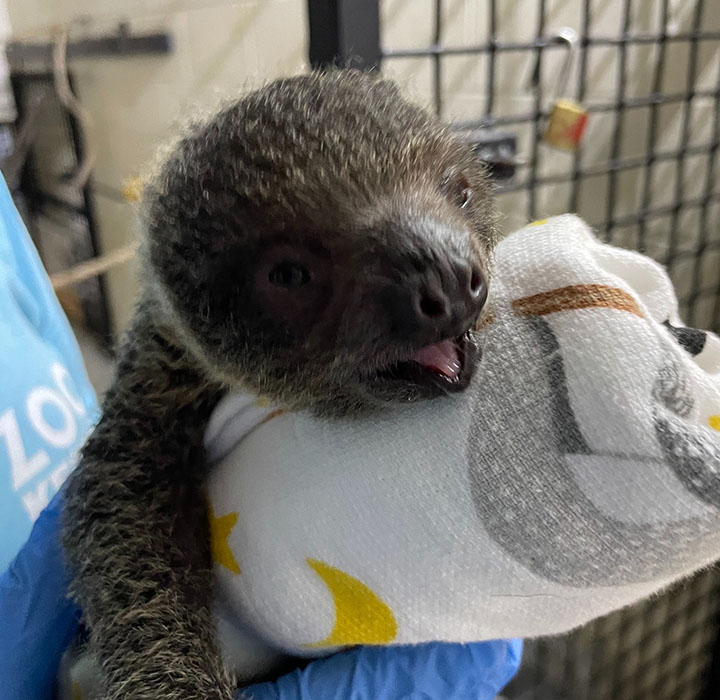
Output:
[{"xmin": 348, "ymin": 0, "xmax": 720, "ymax": 700}]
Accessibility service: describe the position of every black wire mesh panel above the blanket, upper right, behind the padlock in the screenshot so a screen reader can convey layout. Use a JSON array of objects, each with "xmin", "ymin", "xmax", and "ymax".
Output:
[{"xmin": 380, "ymin": 0, "xmax": 720, "ymax": 329}]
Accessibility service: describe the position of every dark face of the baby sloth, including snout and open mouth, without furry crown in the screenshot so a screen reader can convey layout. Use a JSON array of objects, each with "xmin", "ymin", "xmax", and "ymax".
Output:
[{"xmin": 174, "ymin": 180, "xmax": 488, "ymax": 410}]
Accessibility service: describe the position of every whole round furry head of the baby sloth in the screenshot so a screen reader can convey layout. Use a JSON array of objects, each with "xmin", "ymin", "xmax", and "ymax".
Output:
[{"xmin": 145, "ymin": 71, "xmax": 494, "ymax": 412}]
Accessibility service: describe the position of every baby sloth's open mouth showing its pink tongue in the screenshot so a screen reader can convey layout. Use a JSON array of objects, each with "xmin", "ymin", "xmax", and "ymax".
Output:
[{"xmin": 377, "ymin": 330, "xmax": 480, "ymax": 393}]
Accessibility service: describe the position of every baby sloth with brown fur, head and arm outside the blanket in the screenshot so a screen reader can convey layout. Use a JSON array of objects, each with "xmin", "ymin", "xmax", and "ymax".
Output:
[{"xmin": 64, "ymin": 71, "xmax": 495, "ymax": 700}]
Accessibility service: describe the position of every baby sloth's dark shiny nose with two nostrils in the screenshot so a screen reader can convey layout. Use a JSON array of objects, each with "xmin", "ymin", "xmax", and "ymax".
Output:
[{"xmin": 383, "ymin": 257, "xmax": 488, "ymax": 343}]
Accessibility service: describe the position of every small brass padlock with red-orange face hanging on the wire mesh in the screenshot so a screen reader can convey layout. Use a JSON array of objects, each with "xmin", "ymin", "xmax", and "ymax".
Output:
[{"xmin": 543, "ymin": 27, "xmax": 588, "ymax": 150}]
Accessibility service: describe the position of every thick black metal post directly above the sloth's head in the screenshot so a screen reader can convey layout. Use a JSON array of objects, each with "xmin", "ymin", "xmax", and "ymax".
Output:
[{"xmin": 308, "ymin": 0, "xmax": 381, "ymax": 70}]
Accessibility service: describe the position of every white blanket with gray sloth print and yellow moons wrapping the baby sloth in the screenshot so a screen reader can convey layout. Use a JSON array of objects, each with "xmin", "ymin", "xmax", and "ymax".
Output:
[{"xmin": 201, "ymin": 215, "xmax": 720, "ymax": 670}]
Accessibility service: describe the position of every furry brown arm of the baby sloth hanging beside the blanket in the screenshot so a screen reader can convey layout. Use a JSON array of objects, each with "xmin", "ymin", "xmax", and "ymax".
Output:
[{"xmin": 64, "ymin": 304, "xmax": 232, "ymax": 700}]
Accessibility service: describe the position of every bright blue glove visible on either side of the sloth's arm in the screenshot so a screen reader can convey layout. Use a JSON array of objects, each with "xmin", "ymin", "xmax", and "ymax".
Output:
[{"xmin": 0, "ymin": 492, "xmax": 522, "ymax": 700}]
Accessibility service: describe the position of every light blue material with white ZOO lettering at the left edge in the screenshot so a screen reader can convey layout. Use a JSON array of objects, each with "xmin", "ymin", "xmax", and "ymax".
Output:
[{"xmin": 0, "ymin": 174, "xmax": 97, "ymax": 571}]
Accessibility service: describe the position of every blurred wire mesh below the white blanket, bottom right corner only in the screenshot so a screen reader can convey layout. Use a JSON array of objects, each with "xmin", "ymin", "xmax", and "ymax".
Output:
[{"xmin": 501, "ymin": 571, "xmax": 720, "ymax": 700}]
